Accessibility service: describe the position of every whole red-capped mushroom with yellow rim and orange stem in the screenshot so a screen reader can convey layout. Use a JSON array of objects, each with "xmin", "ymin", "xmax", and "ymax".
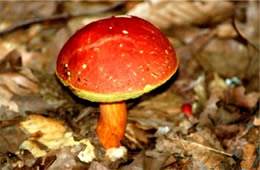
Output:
[{"xmin": 56, "ymin": 16, "xmax": 178, "ymax": 149}]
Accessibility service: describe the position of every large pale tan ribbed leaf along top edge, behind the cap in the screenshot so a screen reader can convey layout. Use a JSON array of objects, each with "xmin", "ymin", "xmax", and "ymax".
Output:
[{"xmin": 128, "ymin": 0, "xmax": 235, "ymax": 29}]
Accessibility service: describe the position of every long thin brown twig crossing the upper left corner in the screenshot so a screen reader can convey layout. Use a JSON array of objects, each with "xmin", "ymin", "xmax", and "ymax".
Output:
[{"xmin": 0, "ymin": 0, "xmax": 125, "ymax": 36}]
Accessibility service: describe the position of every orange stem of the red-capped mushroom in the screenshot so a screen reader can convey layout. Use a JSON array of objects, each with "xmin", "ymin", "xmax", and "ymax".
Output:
[{"xmin": 96, "ymin": 101, "xmax": 127, "ymax": 149}]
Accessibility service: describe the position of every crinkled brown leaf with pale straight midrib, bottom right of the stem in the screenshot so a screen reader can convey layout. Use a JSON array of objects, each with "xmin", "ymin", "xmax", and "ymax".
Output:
[{"xmin": 156, "ymin": 131, "xmax": 232, "ymax": 168}]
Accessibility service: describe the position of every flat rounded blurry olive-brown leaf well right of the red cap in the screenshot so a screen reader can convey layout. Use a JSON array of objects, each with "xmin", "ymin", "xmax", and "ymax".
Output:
[{"xmin": 199, "ymin": 38, "xmax": 250, "ymax": 78}]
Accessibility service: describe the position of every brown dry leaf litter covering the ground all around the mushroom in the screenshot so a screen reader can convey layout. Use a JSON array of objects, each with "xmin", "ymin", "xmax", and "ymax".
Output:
[{"xmin": 0, "ymin": 0, "xmax": 260, "ymax": 170}]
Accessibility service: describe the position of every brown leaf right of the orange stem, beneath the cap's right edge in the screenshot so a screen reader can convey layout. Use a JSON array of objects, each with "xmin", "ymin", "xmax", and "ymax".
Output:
[{"xmin": 128, "ymin": 90, "xmax": 182, "ymax": 129}]
